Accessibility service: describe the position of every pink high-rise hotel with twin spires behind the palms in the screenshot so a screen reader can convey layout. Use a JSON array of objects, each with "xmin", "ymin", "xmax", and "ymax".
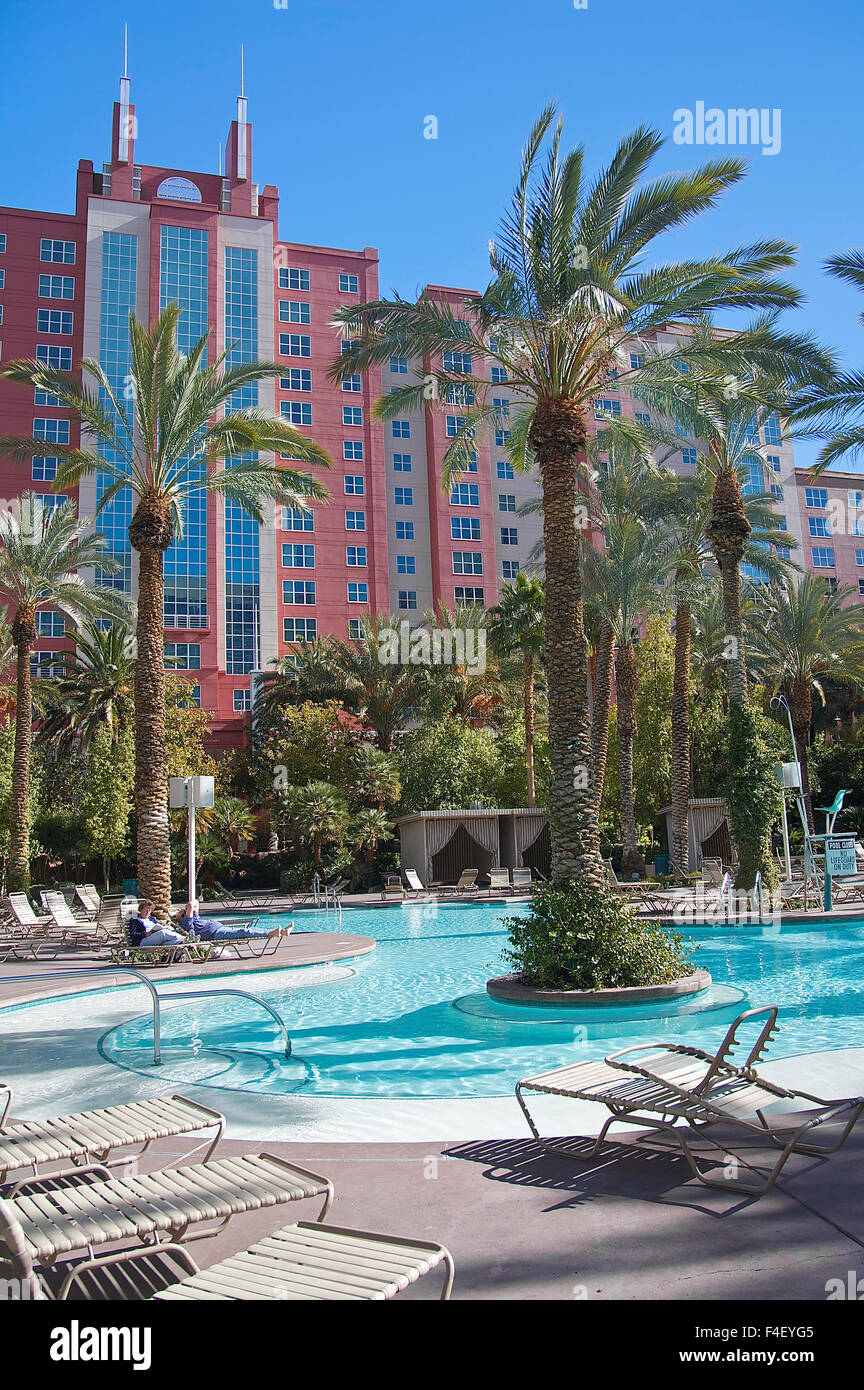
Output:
[{"xmin": 0, "ymin": 78, "xmax": 838, "ymax": 749}]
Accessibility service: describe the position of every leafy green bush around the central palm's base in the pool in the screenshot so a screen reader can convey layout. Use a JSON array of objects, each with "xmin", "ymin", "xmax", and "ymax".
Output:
[{"xmin": 504, "ymin": 883, "xmax": 693, "ymax": 990}]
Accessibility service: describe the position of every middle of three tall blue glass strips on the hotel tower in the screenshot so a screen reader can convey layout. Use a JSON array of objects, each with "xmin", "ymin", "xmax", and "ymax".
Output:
[{"xmin": 160, "ymin": 227, "xmax": 208, "ymax": 628}]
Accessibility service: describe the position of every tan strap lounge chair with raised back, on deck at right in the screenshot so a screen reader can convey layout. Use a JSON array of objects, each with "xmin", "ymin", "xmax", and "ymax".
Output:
[{"xmin": 517, "ymin": 1008, "xmax": 864, "ymax": 1197}]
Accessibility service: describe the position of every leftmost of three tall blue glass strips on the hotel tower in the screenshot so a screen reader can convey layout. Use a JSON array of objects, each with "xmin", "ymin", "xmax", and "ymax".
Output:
[{"xmin": 96, "ymin": 232, "xmax": 138, "ymax": 594}]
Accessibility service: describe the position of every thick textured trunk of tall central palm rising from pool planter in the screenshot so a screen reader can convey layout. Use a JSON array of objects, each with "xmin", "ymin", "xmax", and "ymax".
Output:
[{"xmin": 529, "ymin": 400, "xmax": 606, "ymax": 891}]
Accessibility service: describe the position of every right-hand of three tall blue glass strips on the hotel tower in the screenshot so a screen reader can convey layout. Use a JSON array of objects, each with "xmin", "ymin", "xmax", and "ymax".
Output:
[{"xmin": 225, "ymin": 246, "xmax": 261, "ymax": 676}]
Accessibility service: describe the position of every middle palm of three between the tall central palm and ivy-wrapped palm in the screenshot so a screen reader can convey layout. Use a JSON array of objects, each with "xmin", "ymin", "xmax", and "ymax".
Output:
[{"xmin": 586, "ymin": 517, "xmax": 670, "ymax": 877}]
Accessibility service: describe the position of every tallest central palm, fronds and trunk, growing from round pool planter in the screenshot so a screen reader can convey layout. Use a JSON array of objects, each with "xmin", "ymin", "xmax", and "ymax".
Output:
[{"xmin": 331, "ymin": 107, "xmax": 799, "ymax": 891}]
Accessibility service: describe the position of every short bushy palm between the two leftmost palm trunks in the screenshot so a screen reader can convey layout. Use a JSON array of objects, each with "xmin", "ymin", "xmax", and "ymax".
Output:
[{"xmin": 39, "ymin": 621, "xmax": 135, "ymax": 756}]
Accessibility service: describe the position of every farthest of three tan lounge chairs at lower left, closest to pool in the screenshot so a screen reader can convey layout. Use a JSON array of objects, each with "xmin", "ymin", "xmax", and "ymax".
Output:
[{"xmin": 0, "ymin": 1081, "xmax": 225, "ymax": 1184}]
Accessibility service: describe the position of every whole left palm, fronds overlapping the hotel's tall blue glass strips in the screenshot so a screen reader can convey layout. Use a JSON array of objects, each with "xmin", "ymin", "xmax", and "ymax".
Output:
[{"xmin": 0, "ymin": 304, "xmax": 329, "ymax": 915}]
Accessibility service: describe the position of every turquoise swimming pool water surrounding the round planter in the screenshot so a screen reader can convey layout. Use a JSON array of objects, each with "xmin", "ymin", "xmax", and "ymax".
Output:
[{"xmin": 100, "ymin": 905, "xmax": 864, "ymax": 1097}]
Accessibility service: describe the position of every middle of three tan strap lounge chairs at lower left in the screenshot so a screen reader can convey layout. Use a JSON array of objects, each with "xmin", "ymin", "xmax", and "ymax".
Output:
[{"xmin": 0, "ymin": 1152, "xmax": 333, "ymax": 1298}]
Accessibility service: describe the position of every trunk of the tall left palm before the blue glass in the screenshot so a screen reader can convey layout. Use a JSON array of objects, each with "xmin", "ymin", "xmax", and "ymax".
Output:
[{"xmin": 135, "ymin": 547, "xmax": 171, "ymax": 917}]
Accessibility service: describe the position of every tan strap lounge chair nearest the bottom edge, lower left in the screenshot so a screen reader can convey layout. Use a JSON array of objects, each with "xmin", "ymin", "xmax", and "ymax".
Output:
[{"xmin": 0, "ymin": 1204, "xmax": 453, "ymax": 1302}]
